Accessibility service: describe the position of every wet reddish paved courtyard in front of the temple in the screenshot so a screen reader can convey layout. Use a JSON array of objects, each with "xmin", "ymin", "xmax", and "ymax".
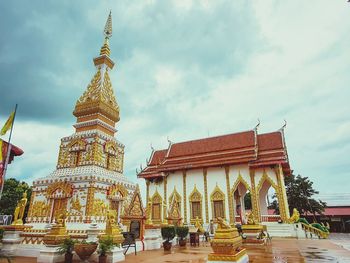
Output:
[{"xmin": 0, "ymin": 234, "xmax": 350, "ymax": 263}]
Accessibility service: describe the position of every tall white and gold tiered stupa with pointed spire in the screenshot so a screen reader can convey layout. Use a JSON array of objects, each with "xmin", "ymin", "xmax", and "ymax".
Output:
[{"xmin": 26, "ymin": 14, "xmax": 138, "ymax": 229}]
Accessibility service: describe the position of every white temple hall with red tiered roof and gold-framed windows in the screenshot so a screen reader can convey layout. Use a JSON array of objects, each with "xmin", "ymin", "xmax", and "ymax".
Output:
[{"xmin": 138, "ymin": 127, "xmax": 291, "ymax": 228}]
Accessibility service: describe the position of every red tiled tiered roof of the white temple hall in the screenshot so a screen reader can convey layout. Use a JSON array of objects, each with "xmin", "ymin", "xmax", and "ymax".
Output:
[{"xmin": 138, "ymin": 130, "xmax": 290, "ymax": 178}]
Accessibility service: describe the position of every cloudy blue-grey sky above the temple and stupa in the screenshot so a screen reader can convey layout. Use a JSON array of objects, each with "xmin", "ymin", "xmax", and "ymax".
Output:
[{"xmin": 0, "ymin": 0, "xmax": 350, "ymax": 202}]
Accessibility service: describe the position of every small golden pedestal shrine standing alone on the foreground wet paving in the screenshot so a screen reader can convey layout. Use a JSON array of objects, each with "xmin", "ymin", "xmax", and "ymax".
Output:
[{"xmin": 208, "ymin": 217, "xmax": 249, "ymax": 262}]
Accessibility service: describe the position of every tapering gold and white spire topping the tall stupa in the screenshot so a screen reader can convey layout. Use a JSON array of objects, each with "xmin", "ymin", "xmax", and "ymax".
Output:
[{"xmin": 73, "ymin": 12, "xmax": 119, "ymax": 136}]
